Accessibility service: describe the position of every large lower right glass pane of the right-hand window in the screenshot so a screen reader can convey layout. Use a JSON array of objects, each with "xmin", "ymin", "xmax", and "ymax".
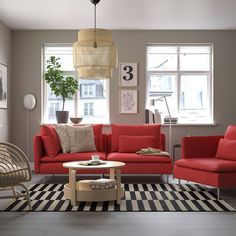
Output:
[{"xmin": 180, "ymin": 75, "xmax": 209, "ymax": 123}]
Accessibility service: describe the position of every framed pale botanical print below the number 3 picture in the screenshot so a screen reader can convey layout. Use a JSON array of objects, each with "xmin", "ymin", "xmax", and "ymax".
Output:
[{"xmin": 120, "ymin": 89, "xmax": 138, "ymax": 114}]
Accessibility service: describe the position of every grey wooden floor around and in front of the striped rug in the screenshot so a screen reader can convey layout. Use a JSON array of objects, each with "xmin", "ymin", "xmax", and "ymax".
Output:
[{"xmin": 0, "ymin": 175, "xmax": 236, "ymax": 236}]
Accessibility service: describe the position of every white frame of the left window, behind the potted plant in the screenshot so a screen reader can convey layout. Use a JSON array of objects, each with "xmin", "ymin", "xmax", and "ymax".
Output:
[{"xmin": 41, "ymin": 43, "xmax": 110, "ymax": 124}]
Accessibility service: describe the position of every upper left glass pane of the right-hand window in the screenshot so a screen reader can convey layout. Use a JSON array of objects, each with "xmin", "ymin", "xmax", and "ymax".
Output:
[{"xmin": 147, "ymin": 54, "xmax": 177, "ymax": 71}]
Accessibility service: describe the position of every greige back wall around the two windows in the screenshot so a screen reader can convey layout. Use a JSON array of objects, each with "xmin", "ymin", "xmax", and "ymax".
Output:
[{"xmin": 12, "ymin": 30, "xmax": 236, "ymax": 160}]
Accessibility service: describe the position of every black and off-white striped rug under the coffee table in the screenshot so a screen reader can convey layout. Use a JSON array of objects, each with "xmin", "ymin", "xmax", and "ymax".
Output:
[{"xmin": 0, "ymin": 184, "xmax": 235, "ymax": 212}]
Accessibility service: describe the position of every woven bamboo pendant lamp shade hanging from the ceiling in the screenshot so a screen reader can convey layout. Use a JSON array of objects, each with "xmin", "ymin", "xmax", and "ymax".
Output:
[{"xmin": 73, "ymin": 29, "xmax": 118, "ymax": 79}]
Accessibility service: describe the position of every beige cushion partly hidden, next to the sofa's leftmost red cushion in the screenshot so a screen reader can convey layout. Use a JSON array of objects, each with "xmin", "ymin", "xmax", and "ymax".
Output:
[{"xmin": 55, "ymin": 125, "xmax": 70, "ymax": 153}]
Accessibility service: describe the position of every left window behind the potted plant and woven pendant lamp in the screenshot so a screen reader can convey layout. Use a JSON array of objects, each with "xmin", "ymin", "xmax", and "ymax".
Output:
[{"xmin": 42, "ymin": 45, "xmax": 109, "ymax": 123}]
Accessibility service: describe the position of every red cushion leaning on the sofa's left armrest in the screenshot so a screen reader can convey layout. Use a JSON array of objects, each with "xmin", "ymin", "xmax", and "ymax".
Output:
[{"xmin": 40, "ymin": 125, "xmax": 61, "ymax": 157}]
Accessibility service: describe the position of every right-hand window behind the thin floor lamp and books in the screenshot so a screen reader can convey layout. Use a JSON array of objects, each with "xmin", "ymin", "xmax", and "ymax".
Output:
[{"xmin": 147, "ymin": 44, "xmax": 213, "ymax": 124}]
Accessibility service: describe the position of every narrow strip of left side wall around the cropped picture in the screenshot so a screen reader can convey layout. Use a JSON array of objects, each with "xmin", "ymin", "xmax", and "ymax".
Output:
[{"xmin": 0, "ymin": 22, "xmax": 12, "ymax": 141}]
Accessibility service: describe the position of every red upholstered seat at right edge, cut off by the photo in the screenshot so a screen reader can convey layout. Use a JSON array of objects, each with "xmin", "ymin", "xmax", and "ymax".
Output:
[{"xmin": 174, "ymin": 125, "xmax": 236, "ymax": 199}]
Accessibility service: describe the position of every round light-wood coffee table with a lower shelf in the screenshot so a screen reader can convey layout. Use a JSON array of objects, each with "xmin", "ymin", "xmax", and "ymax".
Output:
[{"xmin": 63, "ymin": 161, "xmax": 125, "ymax": 206}]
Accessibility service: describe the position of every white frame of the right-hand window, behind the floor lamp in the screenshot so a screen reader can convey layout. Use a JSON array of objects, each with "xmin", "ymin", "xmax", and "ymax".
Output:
[{"xmin": 146, "ymin": 43, "xmax": 215, "ymax": 125}]
